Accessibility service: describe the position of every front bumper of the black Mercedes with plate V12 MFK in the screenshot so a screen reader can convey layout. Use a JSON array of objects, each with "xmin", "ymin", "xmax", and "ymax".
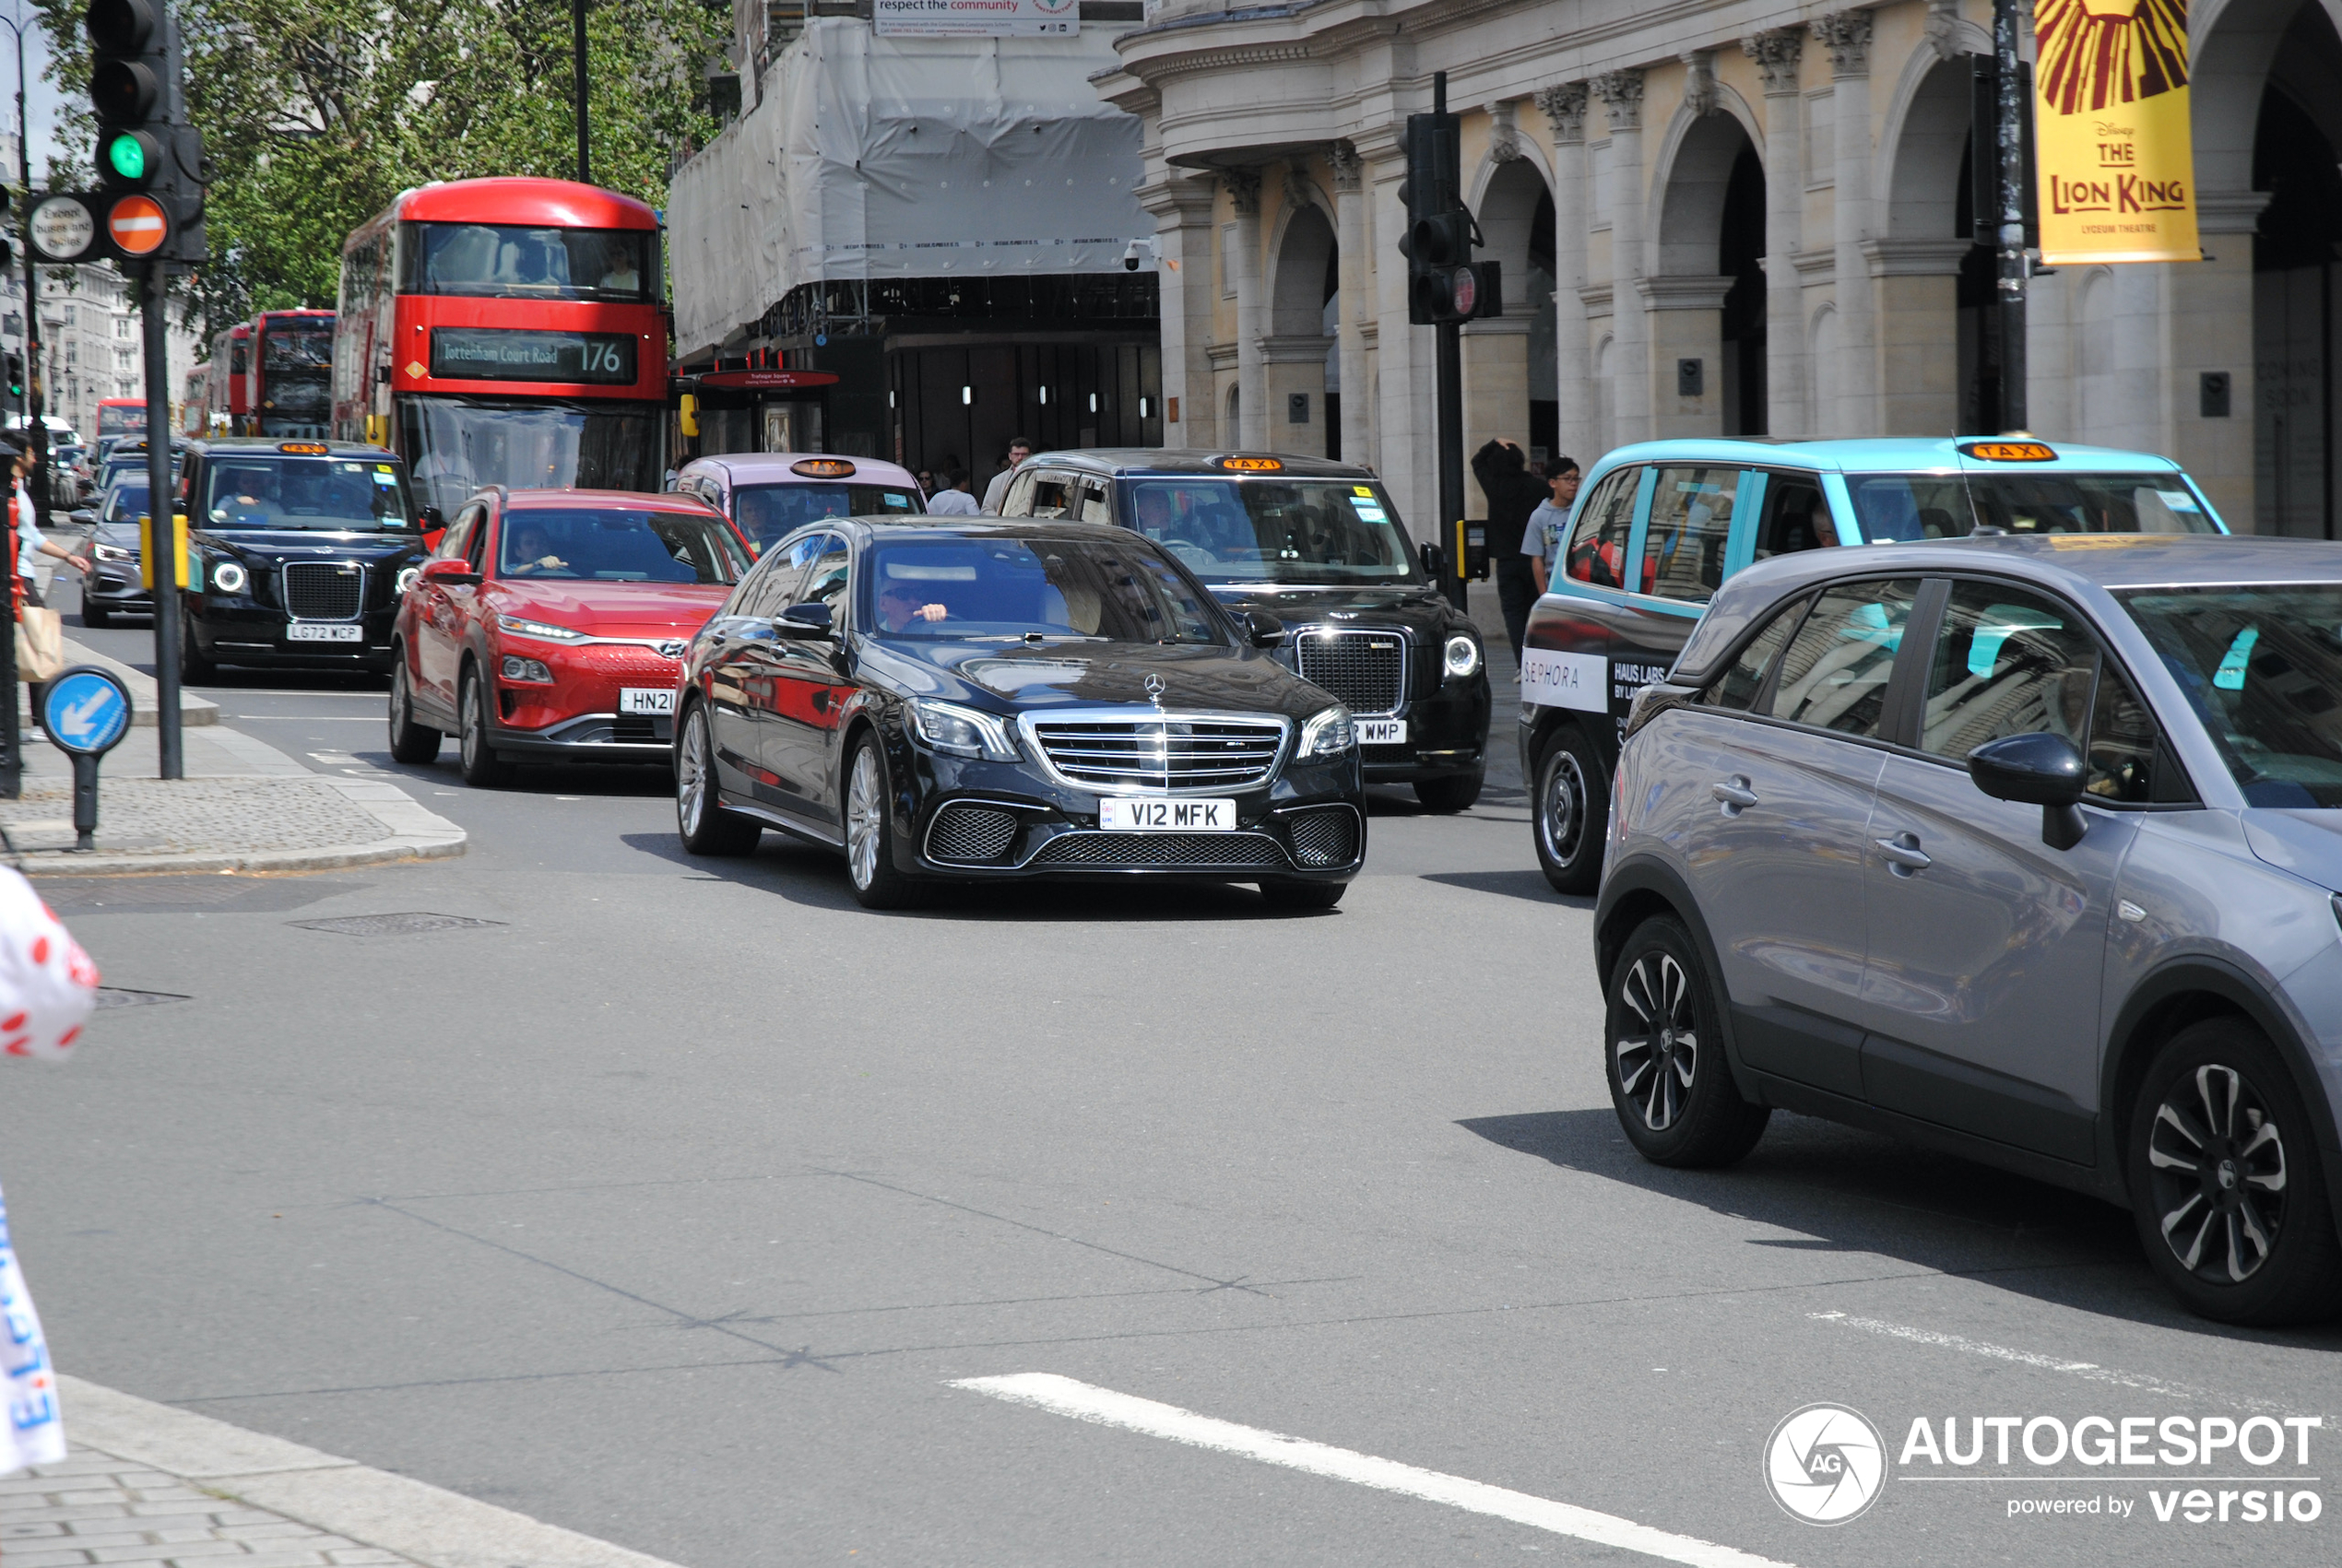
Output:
[{"xmin": 888, "ymin": 735, "xmax": 1366, "ymax": 882}]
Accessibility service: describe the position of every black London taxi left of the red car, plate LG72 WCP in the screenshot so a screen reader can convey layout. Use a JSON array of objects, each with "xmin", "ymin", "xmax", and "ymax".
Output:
[{"xmin": 178, "ymin": 435, "xmax": 426, "ymax": 681}]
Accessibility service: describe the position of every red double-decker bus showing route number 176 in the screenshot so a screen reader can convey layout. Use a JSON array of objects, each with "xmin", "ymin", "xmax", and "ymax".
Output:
[{"xmin": 333, "ymin": 178, "xmax": 668, "ymax": 517}]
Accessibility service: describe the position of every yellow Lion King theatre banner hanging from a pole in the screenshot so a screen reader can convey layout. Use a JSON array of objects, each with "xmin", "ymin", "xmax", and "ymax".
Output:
[{"xmin": 2033, "ymin": 0, "xmax": 2204, "ymax": 266}]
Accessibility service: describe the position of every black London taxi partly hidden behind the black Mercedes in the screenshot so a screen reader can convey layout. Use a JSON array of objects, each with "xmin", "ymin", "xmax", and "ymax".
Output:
[{"xmin": 1000, "ymin": 449, "xmax": 1489, "ymax": 812}]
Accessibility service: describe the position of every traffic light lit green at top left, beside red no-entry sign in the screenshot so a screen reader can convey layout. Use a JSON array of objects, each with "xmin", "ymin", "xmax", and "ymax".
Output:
[{"xmin": 82, "ymin": 0, "xmax": 204, "ymax": 262}]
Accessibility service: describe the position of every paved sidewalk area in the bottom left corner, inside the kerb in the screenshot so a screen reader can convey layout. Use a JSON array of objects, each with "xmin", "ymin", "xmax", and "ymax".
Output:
[{"xmin": 0, "ymin": 1444, "xmax": 415, "ymax": 1568}]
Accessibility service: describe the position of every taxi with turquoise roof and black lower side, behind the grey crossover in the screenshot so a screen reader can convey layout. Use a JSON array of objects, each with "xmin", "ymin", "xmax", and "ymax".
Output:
[{"xmin": 1520, "ymin": 435, "xmax": 2228, "ymax": 894}]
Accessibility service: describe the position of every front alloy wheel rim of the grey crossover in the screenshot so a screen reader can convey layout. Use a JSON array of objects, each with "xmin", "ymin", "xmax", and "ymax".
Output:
[{"xmin": 2147, "ymin": 1063, "xmax": 2286, "ymax": 1285}]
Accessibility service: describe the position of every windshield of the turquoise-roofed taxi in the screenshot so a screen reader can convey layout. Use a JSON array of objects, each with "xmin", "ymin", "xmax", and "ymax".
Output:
[{"xmin": 1846, "ymin": 468, "xmax": 2220, "ymax": 543}]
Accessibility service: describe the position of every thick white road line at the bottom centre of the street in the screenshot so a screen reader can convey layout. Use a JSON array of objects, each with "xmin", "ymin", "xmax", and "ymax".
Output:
[{"xmin": 951, "ymin": 1372, "xmax": 1784, "ymax": 1568}]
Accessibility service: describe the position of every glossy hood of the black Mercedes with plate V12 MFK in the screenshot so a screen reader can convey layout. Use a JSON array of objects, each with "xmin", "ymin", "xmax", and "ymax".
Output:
[{"xmin": 864, "ymin": 642, "xmax": 1326, "ymax": 718}]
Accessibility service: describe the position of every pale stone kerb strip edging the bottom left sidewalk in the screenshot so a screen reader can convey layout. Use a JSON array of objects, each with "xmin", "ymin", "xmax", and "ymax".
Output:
[{"xmin": 56, "ymin": 1372, "xmax": 675, "ymax": 1568}]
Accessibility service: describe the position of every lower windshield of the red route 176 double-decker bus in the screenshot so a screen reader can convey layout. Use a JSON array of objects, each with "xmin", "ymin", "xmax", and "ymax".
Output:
[{"xmin": 398, "ymin": 398, "xmax": 665, "ymax": 517}]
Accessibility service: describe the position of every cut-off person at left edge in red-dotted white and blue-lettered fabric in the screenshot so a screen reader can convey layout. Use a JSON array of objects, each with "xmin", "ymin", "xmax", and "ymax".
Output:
[{"xmin": 0, "ymin": 868, "xmax": 99, "ymax": 1477}]
